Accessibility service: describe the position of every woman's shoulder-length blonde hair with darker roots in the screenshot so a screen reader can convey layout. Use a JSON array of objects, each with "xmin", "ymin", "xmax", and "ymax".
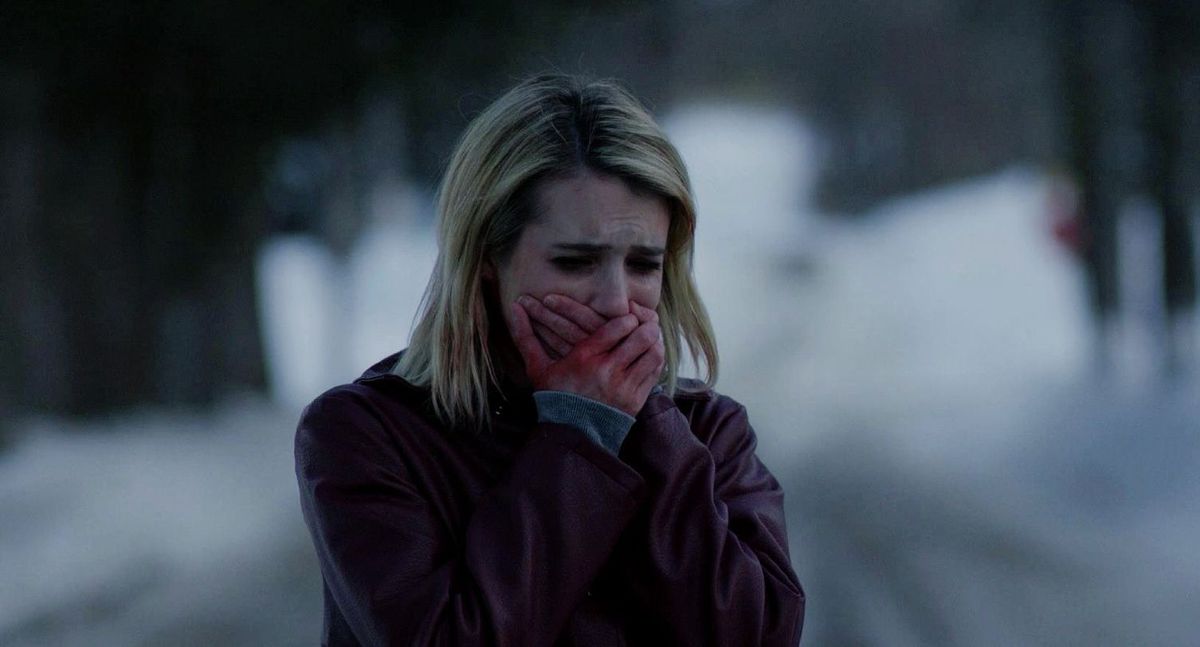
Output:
[{"xmin": 394, "ymin": 74, "xmax": 718, "ymax": 430}]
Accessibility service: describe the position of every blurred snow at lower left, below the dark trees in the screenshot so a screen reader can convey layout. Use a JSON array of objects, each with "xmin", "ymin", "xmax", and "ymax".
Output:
[{"xmin": 0, "ymin": 400, "xmax": 320, "ymax": 645}]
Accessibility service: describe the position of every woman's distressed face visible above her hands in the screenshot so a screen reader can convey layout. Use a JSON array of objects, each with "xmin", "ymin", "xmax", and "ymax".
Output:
[{"xmin": 485, "ymin": 172, "xmax": 670, "ymax": 328}]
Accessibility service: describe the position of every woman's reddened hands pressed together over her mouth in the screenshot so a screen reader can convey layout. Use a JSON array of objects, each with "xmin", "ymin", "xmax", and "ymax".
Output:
[{"xmin": 510, "ymin": 295, "xmax": 666, "ymax": 415}]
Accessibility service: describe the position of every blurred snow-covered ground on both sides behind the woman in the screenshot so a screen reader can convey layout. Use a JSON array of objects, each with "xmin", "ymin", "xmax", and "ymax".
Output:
[{"xmin": 0, "ymin": 106, "xmax": 1200, "ymax": 646}]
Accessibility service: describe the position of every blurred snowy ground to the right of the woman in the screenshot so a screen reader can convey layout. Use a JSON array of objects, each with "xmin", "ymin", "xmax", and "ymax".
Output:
[{"xmin": 682, "ymin": 105, "xmax": 1200, "ymax": 646}]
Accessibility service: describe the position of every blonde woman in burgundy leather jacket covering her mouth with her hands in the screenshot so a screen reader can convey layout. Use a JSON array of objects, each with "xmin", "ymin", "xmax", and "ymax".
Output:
[{"xmin": 296, "ymin": 76, "xmax": 804, "ymax": 646}]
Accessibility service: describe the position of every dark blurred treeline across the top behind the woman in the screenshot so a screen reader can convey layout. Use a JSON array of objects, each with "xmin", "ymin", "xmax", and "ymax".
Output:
[{"xmin": 0, "ymin": 0, "xmax": 1198, "ymax": 418}]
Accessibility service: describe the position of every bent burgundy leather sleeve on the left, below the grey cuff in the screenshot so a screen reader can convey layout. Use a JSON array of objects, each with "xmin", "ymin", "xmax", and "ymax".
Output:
[{"xmin": 295, "ymin": 395, "xmax": 642, "ymax": 646}]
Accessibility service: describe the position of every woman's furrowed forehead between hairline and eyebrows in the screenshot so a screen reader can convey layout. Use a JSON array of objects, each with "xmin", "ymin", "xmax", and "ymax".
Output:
[{"xmin": 530, "ymin": 172, "xmax": 670, "ymax": 246}]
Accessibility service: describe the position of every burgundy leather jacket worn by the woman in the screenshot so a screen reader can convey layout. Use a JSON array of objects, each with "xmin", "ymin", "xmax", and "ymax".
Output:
[{"xmin": 295, "ymin": 354, "xmax": 804, "ymax": 646}]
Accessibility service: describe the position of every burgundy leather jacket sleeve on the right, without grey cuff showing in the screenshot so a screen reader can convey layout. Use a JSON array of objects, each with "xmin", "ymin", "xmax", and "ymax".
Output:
[{"xmin": 620, "ymin": 396, "xmax": 804, "ymax": 646}]
